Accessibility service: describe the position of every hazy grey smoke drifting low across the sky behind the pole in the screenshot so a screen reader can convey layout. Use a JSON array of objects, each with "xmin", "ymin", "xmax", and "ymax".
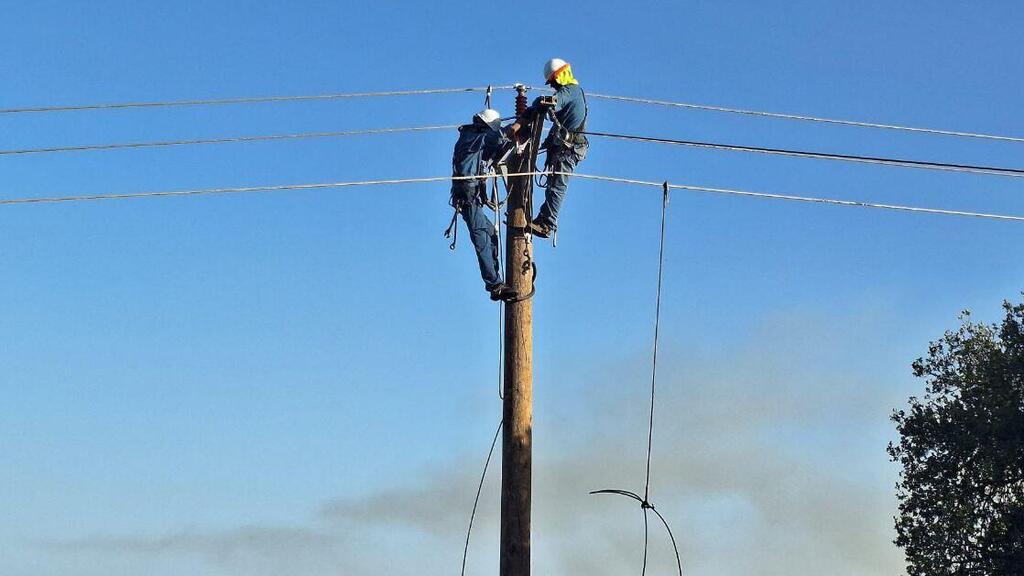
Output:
[{"xmin": 29, "ymin": 309, "xmax": 907, "ymax": 576}]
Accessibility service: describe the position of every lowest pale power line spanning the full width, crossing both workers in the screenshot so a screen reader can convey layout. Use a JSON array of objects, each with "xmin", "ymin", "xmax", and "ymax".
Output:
[{"xmin": 0, "ymin": 171, "xmax": 1024, "ymax": 221}]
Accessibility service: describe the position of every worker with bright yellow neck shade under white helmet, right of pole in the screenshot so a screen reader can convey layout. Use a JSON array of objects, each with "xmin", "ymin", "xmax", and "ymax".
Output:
[{"xmin": 511, "ymin": 58, "xmax": 589, "ymax": 238}]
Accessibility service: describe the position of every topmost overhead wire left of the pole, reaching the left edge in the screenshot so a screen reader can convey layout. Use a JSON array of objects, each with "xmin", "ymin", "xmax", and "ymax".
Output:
[{"xmin": 0, "ymin": 86, "xmax": 512, "ymax": 114}]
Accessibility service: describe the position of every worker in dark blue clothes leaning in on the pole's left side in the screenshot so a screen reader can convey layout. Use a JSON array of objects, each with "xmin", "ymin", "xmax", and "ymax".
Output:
[{"xmin": 452, "ymin": 109, "xmax": 516, "ymax": 301}]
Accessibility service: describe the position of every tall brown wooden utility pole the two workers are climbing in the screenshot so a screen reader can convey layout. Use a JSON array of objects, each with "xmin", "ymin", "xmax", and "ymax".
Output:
[{"xmin": 500, "ymin": 86, "xmax": 544, "ymax": 576}]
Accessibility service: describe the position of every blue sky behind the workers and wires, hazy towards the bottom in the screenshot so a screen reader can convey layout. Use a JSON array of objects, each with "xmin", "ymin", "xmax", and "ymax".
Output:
[{"xmin": 0, "ymin": 0, "xmax": 1024, "ymax": 576}]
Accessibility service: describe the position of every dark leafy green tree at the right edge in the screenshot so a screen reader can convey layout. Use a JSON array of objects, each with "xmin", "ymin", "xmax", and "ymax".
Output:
[{"xmin": 889, "ymin": 302, "xmax": 1024, "ymax": 576}]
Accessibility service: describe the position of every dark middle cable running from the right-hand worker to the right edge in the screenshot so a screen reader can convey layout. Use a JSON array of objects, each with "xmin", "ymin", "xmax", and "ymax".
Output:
[{"xmin": 582, "ymin": 132, "xmax": 1024, "ymax": 178}]
